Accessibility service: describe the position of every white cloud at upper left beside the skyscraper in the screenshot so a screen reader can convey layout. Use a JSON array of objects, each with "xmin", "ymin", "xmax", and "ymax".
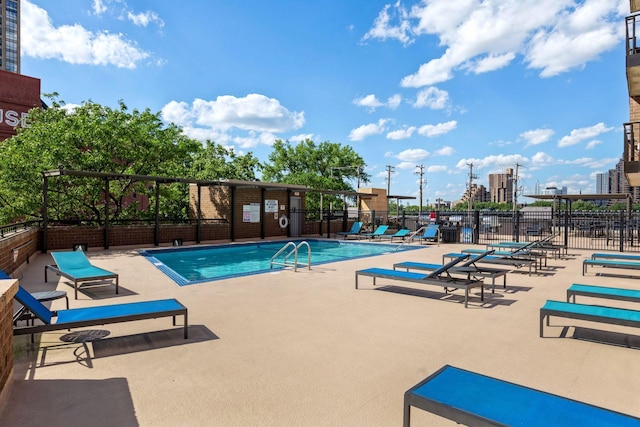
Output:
[{"xmin": 20, "ymin": 0, "xmax": 150, "ymax": 68}]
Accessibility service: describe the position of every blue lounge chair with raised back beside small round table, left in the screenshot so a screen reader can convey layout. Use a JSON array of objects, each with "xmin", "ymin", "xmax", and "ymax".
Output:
[{"xmin": 13, "ymin": 286, "xmax": 188, "ymax": 342}]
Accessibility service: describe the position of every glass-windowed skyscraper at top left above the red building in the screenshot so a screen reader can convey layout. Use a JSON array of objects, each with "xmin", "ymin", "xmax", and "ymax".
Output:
[{"xmin": 0, "ymin": 0, "xmax": 20, "ymax": 74}]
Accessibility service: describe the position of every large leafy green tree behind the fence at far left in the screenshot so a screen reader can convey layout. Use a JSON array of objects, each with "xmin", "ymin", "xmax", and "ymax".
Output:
[{"xmin": 0, "ymin": 94, "xmax": 202, "ymax": 223}]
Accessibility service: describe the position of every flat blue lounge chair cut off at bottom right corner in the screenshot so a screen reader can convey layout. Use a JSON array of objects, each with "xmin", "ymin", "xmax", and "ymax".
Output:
[{"xmin": 404, "ymin": 365, "xmax": 640, "ymax": 427}]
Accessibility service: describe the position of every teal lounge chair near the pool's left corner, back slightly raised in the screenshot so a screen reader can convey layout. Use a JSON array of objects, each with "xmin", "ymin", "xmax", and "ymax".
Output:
[{"xmin": 44, "ymin": 251, "xmax": 118, "ymax": 299}]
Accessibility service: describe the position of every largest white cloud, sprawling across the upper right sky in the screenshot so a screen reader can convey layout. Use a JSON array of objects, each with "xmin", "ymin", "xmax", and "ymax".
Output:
[{"xmin": 363, "ymin": 0, "xmax": 628, "ymax": 87}]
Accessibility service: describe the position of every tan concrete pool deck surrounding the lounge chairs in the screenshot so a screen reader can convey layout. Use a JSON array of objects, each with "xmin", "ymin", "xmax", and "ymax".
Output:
[{"xmin": 0, "ymin": 244, "xmax": 640, "ymax": 427}]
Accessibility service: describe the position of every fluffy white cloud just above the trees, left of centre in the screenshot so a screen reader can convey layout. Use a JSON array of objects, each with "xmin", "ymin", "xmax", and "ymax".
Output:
[{"xmin": 161, "ymin": 94, "xmax": 305, "ymax": 148}]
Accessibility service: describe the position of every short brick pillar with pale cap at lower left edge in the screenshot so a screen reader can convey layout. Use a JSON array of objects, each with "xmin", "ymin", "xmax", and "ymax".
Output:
[{"xmin": 0, "ymin": 279, "xmax": 18, "ymax": 408}]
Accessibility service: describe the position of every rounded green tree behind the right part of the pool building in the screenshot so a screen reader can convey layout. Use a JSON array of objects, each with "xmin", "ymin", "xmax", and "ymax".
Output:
[{"xmin": 262, "ymin": 139, "xmax": 370, "ymax": 210}]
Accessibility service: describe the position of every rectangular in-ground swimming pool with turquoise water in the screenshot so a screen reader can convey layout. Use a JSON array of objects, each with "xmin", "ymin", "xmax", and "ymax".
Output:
[{"xmin": 140, "ymin": 239, "xmax": 420, "ymax": 286}]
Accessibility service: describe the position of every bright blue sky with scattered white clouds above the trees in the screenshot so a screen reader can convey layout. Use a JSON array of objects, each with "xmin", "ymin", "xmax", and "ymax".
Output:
[{"xmin": 21, "ymin": 0, "xmax": 629, "ymax": 204}]
